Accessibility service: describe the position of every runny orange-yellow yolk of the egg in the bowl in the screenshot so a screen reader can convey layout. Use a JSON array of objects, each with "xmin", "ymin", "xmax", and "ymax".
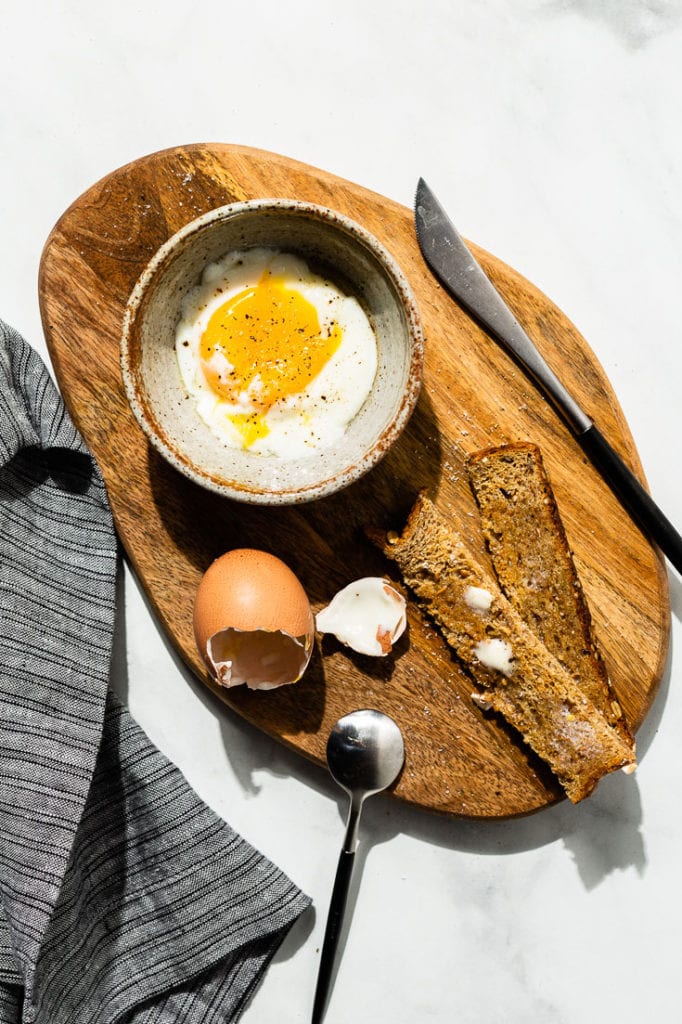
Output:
[{"xmin": 199, "ymin": 272, "xmax": 342, "ymax": 447}]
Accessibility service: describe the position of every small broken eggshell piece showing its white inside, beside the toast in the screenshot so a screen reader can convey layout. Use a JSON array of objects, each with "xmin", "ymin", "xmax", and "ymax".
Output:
[{"xmin": 315, "ymin": 577, "xmax": 407, "ymax": 657}]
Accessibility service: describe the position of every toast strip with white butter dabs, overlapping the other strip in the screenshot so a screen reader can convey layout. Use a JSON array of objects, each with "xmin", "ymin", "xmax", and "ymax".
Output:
[{"xmin": 371, "ymin": 493, "xmax": 635, "ymax": 803}]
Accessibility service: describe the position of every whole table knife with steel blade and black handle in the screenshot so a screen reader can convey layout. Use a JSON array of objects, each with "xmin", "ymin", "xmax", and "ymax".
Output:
[{"xmin": 415, "ymin": 178, "xmax": 682, "ymax": 573}]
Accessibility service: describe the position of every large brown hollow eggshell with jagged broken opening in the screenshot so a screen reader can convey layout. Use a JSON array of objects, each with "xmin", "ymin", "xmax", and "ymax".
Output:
[{"xmin": 194, "ymin": 548, "xmax": 314, "ymax": 689}]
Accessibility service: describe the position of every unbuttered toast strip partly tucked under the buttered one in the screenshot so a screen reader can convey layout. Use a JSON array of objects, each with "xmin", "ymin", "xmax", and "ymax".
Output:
[{"xmin": 467, "ymin": 441, "xmax": 634, "ymax": 745}]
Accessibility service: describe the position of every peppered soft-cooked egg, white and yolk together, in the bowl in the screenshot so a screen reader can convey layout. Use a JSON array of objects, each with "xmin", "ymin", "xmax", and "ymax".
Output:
[{"xmin": 176, "ymin": 248, "xmax": 377, "ymax": 459}]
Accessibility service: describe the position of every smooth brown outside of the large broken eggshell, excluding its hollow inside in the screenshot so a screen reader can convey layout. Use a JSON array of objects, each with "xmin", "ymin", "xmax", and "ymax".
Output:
[{"xmin": 194, "ymin": 548, "xmax": 314, "ymax": 658}]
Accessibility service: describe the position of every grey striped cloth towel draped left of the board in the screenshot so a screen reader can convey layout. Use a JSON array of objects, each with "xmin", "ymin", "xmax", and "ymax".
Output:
[{"xmin": 0, "ymin": 322, "xmax": 308, "ymax": 1024}]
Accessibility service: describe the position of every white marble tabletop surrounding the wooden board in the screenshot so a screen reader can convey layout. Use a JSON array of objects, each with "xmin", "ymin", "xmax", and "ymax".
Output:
[{"xmin": 0, "ymin": 0, "xmax": 682, "ymax": 1024}]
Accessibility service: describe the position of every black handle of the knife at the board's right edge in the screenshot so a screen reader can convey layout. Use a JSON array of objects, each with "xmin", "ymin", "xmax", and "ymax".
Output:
[{"xmin": 578, "ymin": 426, "xmax": 682, "ymax": 573}]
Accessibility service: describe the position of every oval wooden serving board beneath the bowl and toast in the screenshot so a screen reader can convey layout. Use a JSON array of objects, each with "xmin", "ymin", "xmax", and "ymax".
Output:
[{"xmin": 40, "ymin": 144, "xmax": 670, "ymax": 818}]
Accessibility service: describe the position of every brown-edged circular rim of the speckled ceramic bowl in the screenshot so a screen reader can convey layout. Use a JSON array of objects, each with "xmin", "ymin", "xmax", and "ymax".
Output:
[{"xmin": 120, "ymin": 198, "xmax": 424, "ymax": 505}]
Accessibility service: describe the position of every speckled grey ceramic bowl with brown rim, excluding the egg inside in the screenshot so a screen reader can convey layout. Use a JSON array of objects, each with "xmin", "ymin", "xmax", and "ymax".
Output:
[{"xmin": 121, "ymin": 200, "xmax": 424, "ymax": 505}]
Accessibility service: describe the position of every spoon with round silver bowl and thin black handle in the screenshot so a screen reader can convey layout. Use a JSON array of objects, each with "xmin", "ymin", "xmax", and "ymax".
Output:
[{"xmin": 312, "ymin": 710, "xmax": 404, "ymax": 1024}]
